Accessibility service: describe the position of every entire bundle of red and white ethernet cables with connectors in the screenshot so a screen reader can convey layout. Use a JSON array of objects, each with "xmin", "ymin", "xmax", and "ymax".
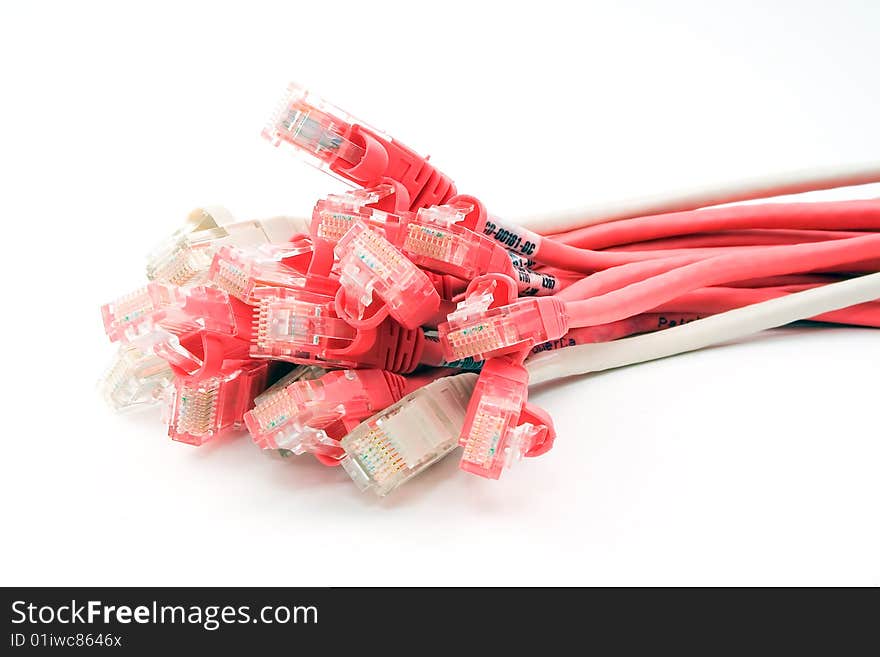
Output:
[{"xmin": 102, "ymin": 80, "xmax": 880, "ymax": 494}]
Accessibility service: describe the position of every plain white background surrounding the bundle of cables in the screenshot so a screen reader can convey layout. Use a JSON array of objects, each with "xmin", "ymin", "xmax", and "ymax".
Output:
[{"xmin": 0, "ymin": 0, "xmax": 880, "ymax": 586}]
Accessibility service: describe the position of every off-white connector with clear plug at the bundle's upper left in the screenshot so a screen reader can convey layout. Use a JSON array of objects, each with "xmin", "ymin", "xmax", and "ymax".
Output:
[{"xmin": 147, "ymin": 208, "xmax": 308, "ymax": 286}]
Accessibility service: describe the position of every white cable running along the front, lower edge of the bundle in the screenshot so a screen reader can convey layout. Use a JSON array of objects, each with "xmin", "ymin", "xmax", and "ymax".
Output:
[{"xmin": 526, "ymin": 273, "xmax": 880, "ymax": 385}]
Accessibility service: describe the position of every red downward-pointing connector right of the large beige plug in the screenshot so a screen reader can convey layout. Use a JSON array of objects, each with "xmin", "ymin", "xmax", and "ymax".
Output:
[{"xmin": 459, "ymin": 363, "xmax": 546, "ymax": 479}]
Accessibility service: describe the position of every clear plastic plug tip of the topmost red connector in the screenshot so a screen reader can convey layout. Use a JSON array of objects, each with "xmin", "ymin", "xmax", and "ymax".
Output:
[{"xmin": 262, "ymin": 83, "xmax": 375, "ymax": 182}]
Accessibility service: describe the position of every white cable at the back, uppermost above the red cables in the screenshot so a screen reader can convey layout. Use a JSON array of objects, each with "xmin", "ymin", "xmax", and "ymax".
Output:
[{"xmin": 511, "ymin": 161, "xmax": 880, "ymax": 235}]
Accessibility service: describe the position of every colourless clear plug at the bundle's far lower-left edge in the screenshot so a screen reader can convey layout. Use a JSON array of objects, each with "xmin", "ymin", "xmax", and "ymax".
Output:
[{"xmin": 99, "ymin": 344, "xmax": 174, "ymax": 411}]
